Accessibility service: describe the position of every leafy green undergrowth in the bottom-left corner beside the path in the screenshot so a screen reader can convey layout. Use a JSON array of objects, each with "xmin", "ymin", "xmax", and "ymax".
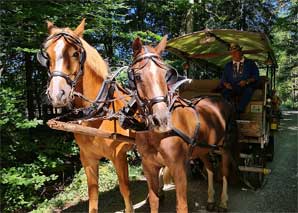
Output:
[{"xmin": 0, "ymin": 129, "xmax": 78, "ymax": 212}]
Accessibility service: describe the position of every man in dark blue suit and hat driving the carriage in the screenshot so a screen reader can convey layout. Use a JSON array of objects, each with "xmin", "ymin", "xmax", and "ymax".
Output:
[{"xmin": 221, "ymin": 43, "xmax": 259, "ymax": 115}]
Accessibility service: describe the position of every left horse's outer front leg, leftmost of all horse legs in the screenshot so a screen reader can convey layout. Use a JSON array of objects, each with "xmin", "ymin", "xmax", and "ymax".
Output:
[{"xmin": 80, "ymin": 151, "xmax": 99, "ymax": 213}]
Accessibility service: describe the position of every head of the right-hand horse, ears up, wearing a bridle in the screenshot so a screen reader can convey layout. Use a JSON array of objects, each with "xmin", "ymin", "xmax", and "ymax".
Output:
[{"xmin": 129, "ymin": 36, "xmax": 171, "ymax": 133}]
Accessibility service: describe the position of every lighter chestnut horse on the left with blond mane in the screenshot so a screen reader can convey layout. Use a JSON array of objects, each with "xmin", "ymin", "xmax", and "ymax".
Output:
[{"xmin": 38, "ymin": 19, "xmax": 134, "ymax": 212}]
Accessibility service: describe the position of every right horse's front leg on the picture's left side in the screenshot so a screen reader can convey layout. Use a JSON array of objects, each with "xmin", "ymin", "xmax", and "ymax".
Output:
[{"xmin": 142, "ymin": 159, "xmax": 160, "ymax": 213}]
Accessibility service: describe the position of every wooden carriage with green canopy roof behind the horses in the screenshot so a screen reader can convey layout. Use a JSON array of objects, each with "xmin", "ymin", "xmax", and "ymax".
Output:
[{"xmin": 167, "ymin": 29, "xmax": 277, "ymax": 188}]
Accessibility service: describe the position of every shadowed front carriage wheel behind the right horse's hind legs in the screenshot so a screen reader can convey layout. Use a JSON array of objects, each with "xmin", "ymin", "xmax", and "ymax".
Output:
[{"xmin": 243, "ymin": 149, "xmax": 266, "ymax": 189}]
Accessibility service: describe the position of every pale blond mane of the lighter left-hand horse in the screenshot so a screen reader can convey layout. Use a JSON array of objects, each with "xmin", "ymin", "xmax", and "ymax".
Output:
[{"xmin": 44, "ymin": 28, "xmax": 108, "ymax": 79}]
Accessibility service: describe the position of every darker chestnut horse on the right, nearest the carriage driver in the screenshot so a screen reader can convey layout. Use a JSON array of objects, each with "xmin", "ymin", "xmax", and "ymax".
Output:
[{"xmin": 129, "ymin": 36, "xmax": 237, "ymax": 212}]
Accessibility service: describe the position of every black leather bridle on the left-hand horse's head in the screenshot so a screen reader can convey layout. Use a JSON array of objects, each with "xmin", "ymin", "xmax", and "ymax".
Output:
[{"xmin": 37, "ymin": 32, "xmax": 86, "ymax": 91}]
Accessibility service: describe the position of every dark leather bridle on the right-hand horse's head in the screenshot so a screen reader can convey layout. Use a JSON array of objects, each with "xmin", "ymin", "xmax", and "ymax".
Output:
[{"xmin": 128, "ymin": 46, "xmax": 169, "ymax": 114}]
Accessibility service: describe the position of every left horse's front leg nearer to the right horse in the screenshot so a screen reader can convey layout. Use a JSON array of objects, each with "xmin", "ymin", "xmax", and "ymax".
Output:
[{"xmin": 112, "ymin": 152, "xmax": 134, "ymax": 212}]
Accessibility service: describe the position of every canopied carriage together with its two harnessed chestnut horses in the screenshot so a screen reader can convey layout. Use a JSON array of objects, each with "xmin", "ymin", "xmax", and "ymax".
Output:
[{"xmin": 37, "ymin": 20, "xmax": 276, "ymax": 212}]
